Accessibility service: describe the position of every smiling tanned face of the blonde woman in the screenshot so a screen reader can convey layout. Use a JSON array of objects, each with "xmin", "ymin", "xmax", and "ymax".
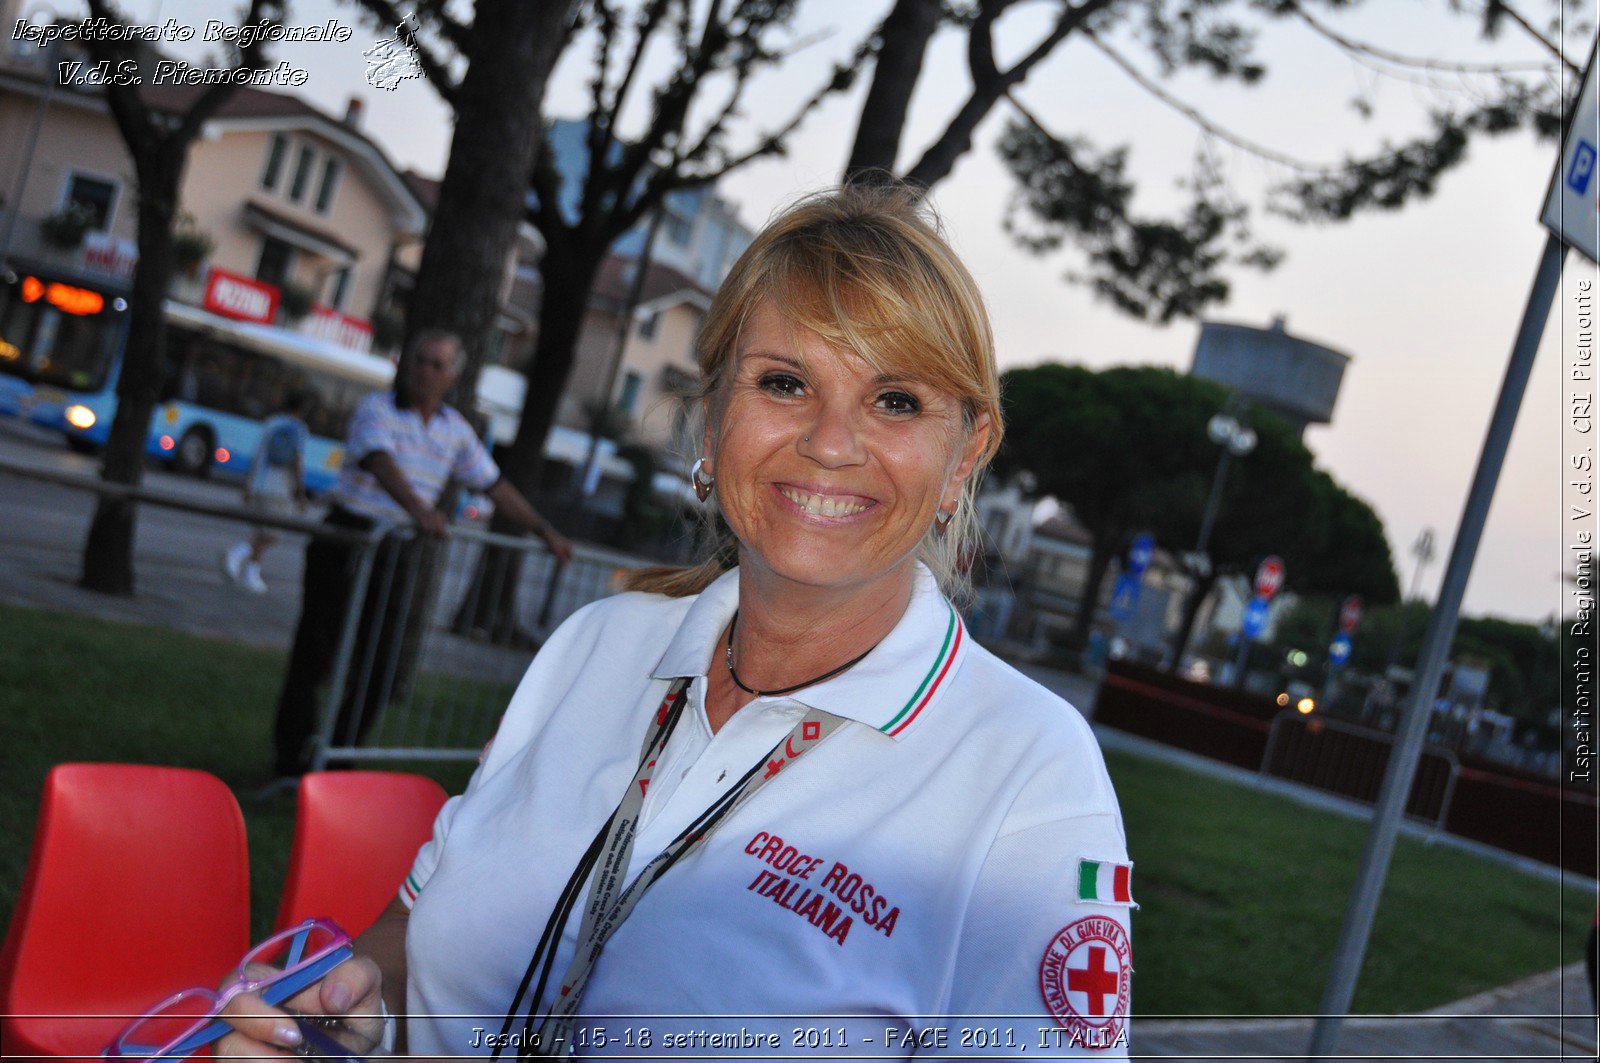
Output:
[{"xmin": 706, "ymin": 303, "xmax": 989, "ymax": 591}]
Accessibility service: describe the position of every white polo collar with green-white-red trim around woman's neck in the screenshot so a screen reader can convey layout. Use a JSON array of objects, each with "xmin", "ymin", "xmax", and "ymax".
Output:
[{"xmin": 651, "ymin": 562, "xmax": 968, "ymax": 738}]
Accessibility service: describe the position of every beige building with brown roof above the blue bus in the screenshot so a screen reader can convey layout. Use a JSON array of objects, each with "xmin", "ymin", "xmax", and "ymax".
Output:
[{"xmin": 0, "ymin": 19, "xmax": 427, "ymax": 351}]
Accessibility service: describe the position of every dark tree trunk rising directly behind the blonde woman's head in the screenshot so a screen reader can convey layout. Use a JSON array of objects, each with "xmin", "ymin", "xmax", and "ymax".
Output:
[{"xmin": 845, "ymin": 0, "xmax": 939, "ymax": 183}]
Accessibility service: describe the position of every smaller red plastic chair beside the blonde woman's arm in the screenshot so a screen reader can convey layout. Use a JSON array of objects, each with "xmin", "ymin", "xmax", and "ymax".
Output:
[{"xmin": 277, "ymin": 772, "xmax": 448, "ymax": 937}]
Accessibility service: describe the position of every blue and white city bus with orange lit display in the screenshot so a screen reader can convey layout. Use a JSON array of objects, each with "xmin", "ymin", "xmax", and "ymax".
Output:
[{"xmin": 0, "ymin": 272, "xmax": 394, "ymax": 491}]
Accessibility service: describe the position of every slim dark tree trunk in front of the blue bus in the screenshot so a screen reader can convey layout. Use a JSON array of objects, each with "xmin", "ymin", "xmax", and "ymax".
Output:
[{"xmin": 80, "ymin": 154, "xmax": 187, "ymax": 596}]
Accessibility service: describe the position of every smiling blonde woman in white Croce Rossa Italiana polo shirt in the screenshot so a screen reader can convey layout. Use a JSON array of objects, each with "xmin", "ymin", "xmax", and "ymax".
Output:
[{"xmin": 222, "ymin": 191, "xmax": 1134, "ymax": 1058}]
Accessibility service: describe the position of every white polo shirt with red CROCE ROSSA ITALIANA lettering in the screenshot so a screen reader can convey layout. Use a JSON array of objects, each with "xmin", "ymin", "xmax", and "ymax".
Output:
[{"xmin": 402, "ymin": 567, "xmax": 1131, "ymax": 1058}]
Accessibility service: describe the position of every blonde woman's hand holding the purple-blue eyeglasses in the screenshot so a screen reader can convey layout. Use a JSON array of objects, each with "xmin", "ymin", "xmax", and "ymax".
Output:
[{"xmin": 216, "ymin": 956, "xmax": 384, "ymax": 1058}]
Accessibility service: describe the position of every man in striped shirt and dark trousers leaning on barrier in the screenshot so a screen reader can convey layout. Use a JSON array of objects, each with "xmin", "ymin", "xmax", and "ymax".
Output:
[{"xmin": 274, "ymin": 330, "xmax": 573, "ymax": 775}]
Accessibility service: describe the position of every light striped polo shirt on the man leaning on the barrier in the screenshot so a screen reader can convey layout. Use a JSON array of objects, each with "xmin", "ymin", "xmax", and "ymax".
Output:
[{"xmin": 328, "ymin": 392, "xmax": 499, "ymax": 520}]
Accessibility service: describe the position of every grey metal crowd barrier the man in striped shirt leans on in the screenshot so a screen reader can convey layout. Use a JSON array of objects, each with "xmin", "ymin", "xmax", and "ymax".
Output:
[{"xmin": 312, "ymin": 525, "xmax": 640, "ymax": 770}]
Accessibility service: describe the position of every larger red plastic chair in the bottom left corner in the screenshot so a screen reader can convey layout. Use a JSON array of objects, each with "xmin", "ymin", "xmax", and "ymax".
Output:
[{"xmin": 0, "ymin": 764, "xmax": 250, "ymax": 1057}]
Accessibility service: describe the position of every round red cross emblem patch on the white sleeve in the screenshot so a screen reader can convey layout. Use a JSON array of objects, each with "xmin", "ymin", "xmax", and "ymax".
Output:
[{"xmin": 1038, "ymin": 916, "xmax": 1133, "ymax": 1049}]
